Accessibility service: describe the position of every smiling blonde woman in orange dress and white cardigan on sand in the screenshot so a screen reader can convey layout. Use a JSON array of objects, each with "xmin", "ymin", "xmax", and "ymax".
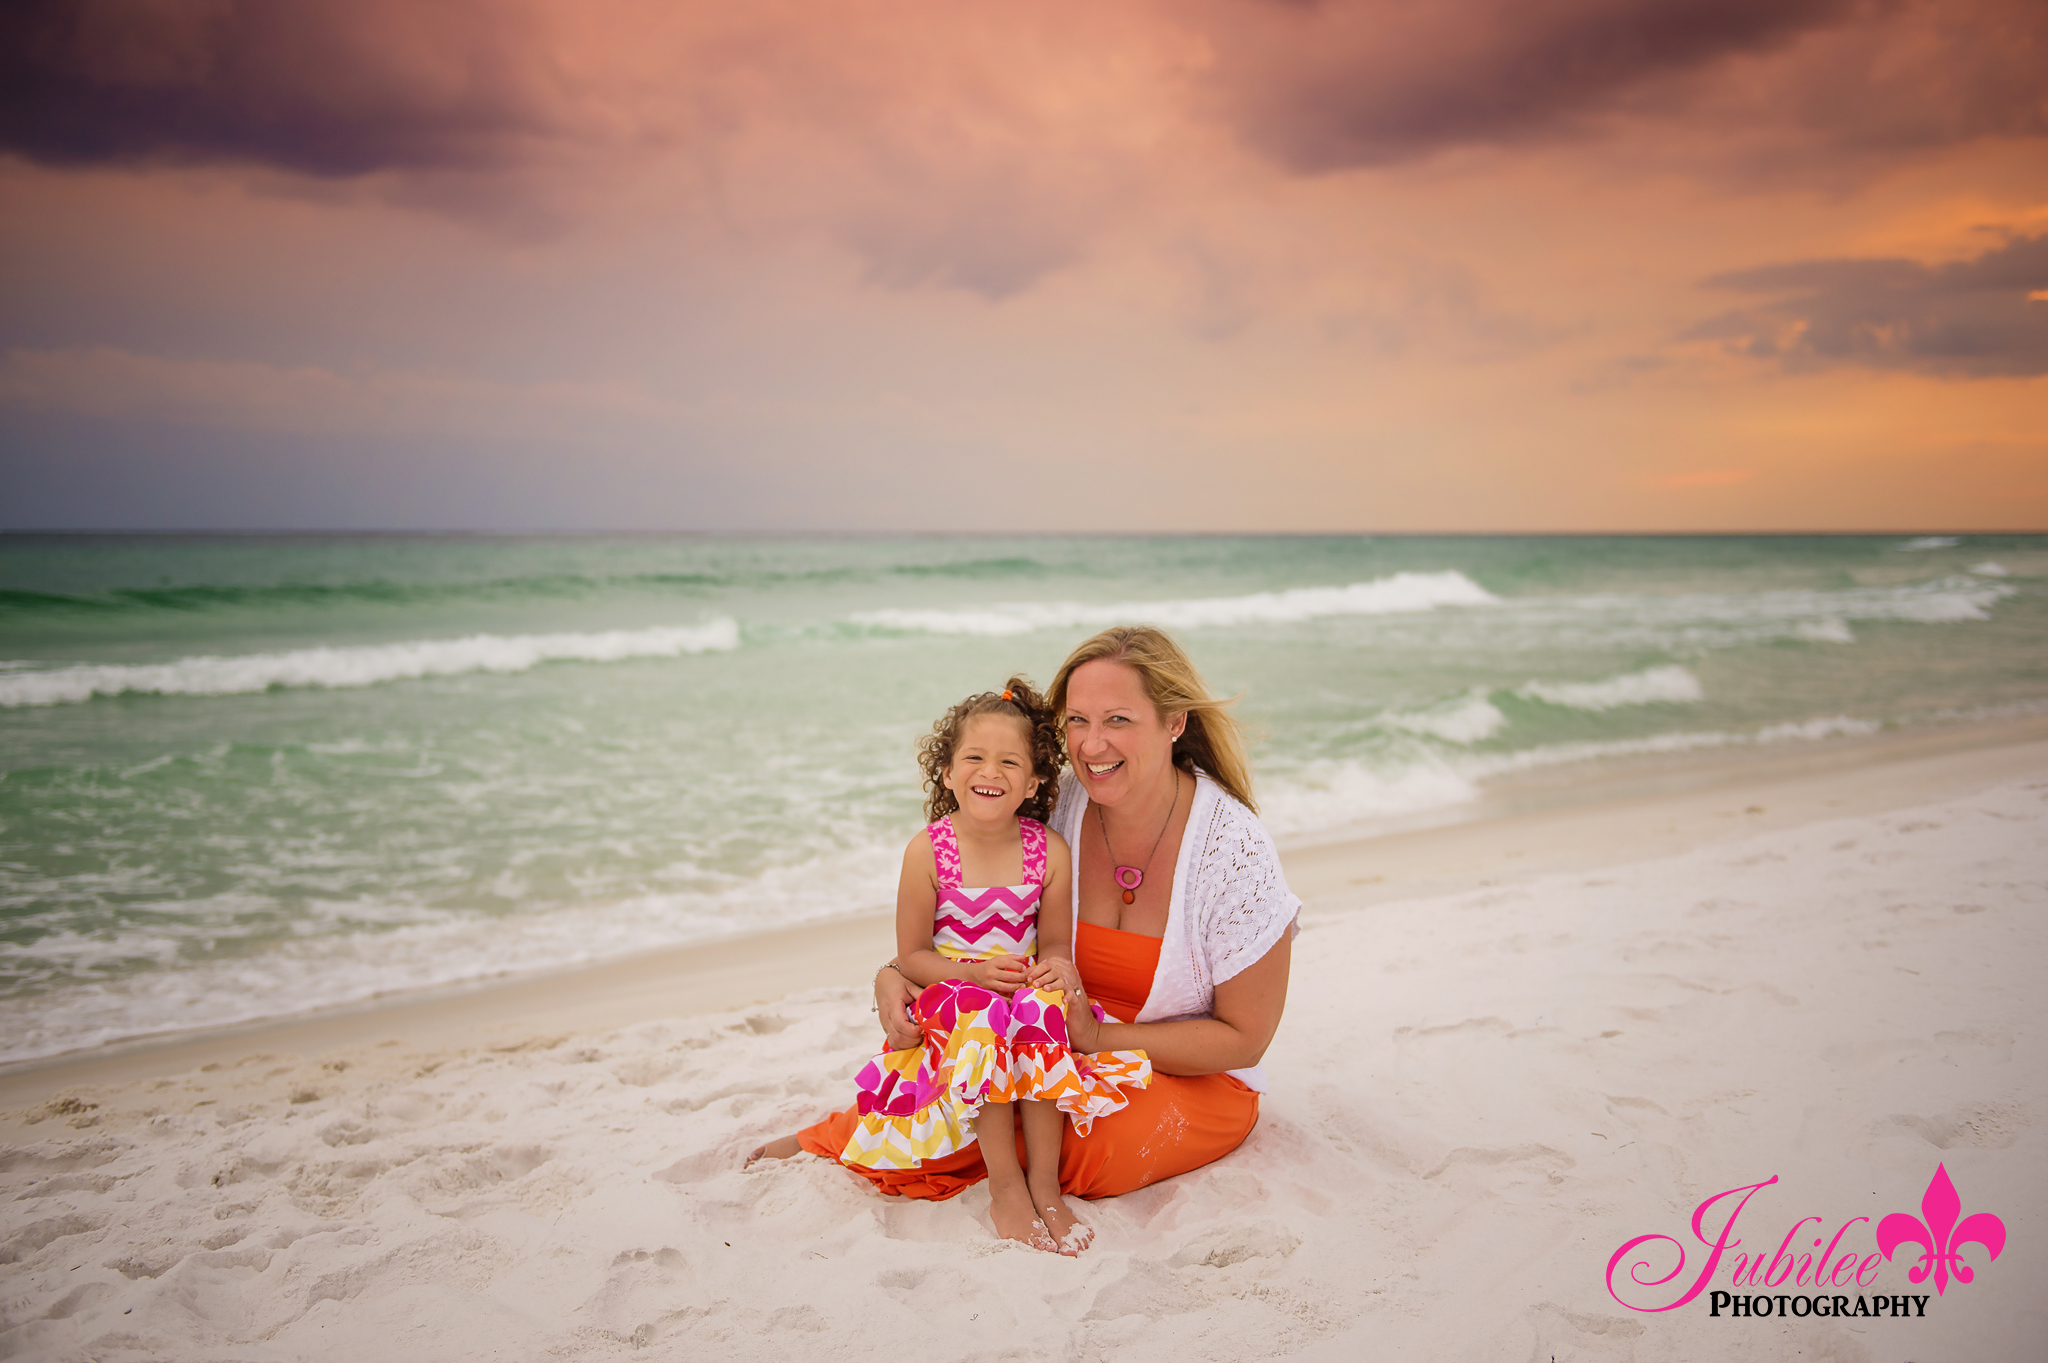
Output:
[{"xmin": 760, "ymin": 626, "xmax": 1300, "ymax": 1199}]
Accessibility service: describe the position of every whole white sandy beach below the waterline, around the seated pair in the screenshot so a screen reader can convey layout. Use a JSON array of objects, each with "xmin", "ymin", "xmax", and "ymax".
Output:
[{"xmin": 0, "ymin": 724, "xmax": 2048, "ymax": 1363}]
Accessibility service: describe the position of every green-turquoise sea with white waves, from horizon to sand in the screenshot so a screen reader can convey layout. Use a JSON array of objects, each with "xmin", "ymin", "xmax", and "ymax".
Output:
[{"xmin": 0, "ymin": 536, "xmax": 2048, "ymax": 1060}]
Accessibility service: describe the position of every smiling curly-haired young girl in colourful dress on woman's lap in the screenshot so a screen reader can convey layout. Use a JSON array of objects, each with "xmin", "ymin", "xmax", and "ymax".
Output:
[{"xmin": 840, "ymin": 677, "xmax": 1151, "ymax": 1255}]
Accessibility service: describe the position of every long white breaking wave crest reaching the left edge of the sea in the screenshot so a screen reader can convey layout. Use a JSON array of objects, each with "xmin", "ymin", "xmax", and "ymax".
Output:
[{"xmin": 0, "ymin": 620, "xmax": 739, "ymax": 708}]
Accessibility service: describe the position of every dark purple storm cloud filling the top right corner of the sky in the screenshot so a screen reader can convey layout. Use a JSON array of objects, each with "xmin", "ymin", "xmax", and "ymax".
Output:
[{"xmin": 1208, "ymin": 0, "xmax": 2048, "ymax": 172}]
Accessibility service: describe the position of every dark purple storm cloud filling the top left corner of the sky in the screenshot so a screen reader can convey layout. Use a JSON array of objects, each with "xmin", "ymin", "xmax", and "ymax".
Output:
[{"xmin": 0, "ymin": 0, "xmax": 551, "ymax": 176}]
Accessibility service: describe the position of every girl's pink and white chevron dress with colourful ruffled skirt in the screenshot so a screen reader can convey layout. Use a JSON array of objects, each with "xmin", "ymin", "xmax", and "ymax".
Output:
[{"xmin": 840, "ymin": 817, "xmax": 1151, "ymax": 1169}]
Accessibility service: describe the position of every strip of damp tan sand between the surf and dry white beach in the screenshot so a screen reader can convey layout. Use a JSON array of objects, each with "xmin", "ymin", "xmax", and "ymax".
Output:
[{"xmin": 0, "ymin": 716, "xmax": 2048, "ymax": 1132}]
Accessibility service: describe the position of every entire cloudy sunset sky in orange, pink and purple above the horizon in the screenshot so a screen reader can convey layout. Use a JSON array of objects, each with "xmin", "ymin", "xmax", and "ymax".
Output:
[{"xmin": 0, "ymin": 0, "xmax": 2048, "ymax": 534}]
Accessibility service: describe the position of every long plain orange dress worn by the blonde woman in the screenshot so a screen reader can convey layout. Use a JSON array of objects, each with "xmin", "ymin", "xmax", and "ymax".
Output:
[{"xmin": 797, "ymin": 923, "xmax": 1260, "ymax": 1201}]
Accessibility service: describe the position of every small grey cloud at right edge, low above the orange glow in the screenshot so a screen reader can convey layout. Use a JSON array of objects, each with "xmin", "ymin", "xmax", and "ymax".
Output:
[{"xmin": 1690, "ymin": 235, "xmax": 2048, "ymax": 379}]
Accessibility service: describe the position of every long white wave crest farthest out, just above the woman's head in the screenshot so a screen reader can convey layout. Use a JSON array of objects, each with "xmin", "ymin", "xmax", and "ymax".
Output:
[{"xmin": 850, "ymin": 573, "xmax": 1499, "ymax": 636}]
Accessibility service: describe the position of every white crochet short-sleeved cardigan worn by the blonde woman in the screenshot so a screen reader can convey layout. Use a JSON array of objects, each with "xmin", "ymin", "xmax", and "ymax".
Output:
[{"xmin": 1053, "ymin": 767, "xmax": 1300, "ymax": 1093}]
